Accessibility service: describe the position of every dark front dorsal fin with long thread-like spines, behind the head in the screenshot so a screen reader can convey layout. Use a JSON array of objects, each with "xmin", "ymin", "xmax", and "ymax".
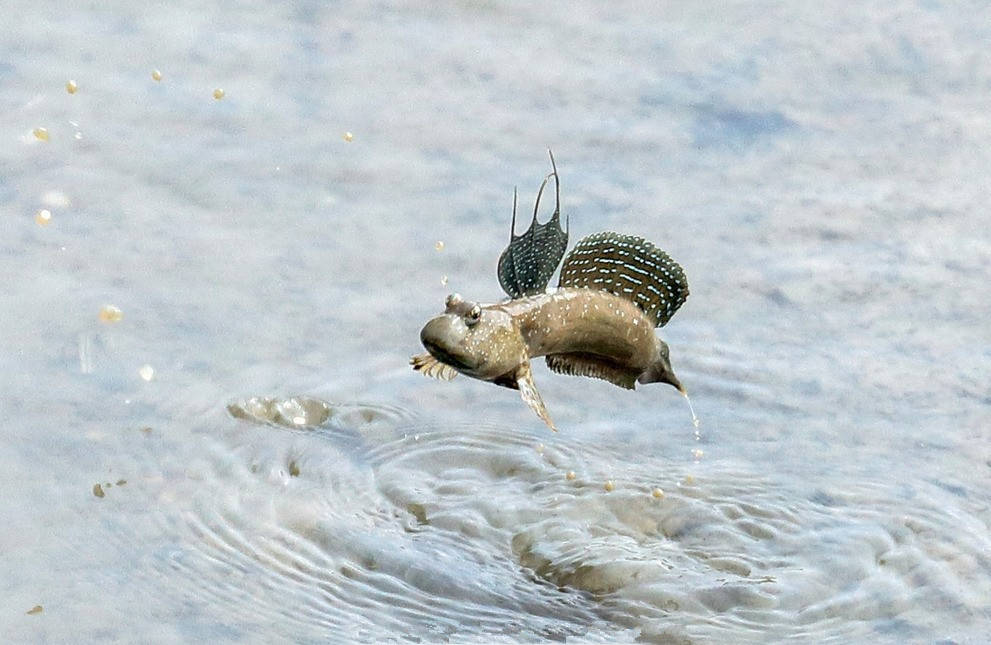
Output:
[{"xmin": 498, "ymin": 154, "xmax": 568, "ymax": 298}]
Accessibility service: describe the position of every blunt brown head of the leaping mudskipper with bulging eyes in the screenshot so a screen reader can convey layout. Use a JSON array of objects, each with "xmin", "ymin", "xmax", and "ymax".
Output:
[{"xmin": 420, "ymin": 294, "xmax": 527, "ymax": 381}]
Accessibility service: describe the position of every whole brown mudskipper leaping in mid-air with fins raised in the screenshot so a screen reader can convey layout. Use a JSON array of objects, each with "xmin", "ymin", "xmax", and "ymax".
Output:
[{"xmin": 410, "ymin": 157, "xmax": 688, "ymax": 430}]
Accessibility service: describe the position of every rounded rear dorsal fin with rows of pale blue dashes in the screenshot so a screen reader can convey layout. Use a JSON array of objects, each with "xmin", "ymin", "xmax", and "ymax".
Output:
[{"xmin": 558, "ymin": 232, "xmax": 688, "ymax": 327}]
